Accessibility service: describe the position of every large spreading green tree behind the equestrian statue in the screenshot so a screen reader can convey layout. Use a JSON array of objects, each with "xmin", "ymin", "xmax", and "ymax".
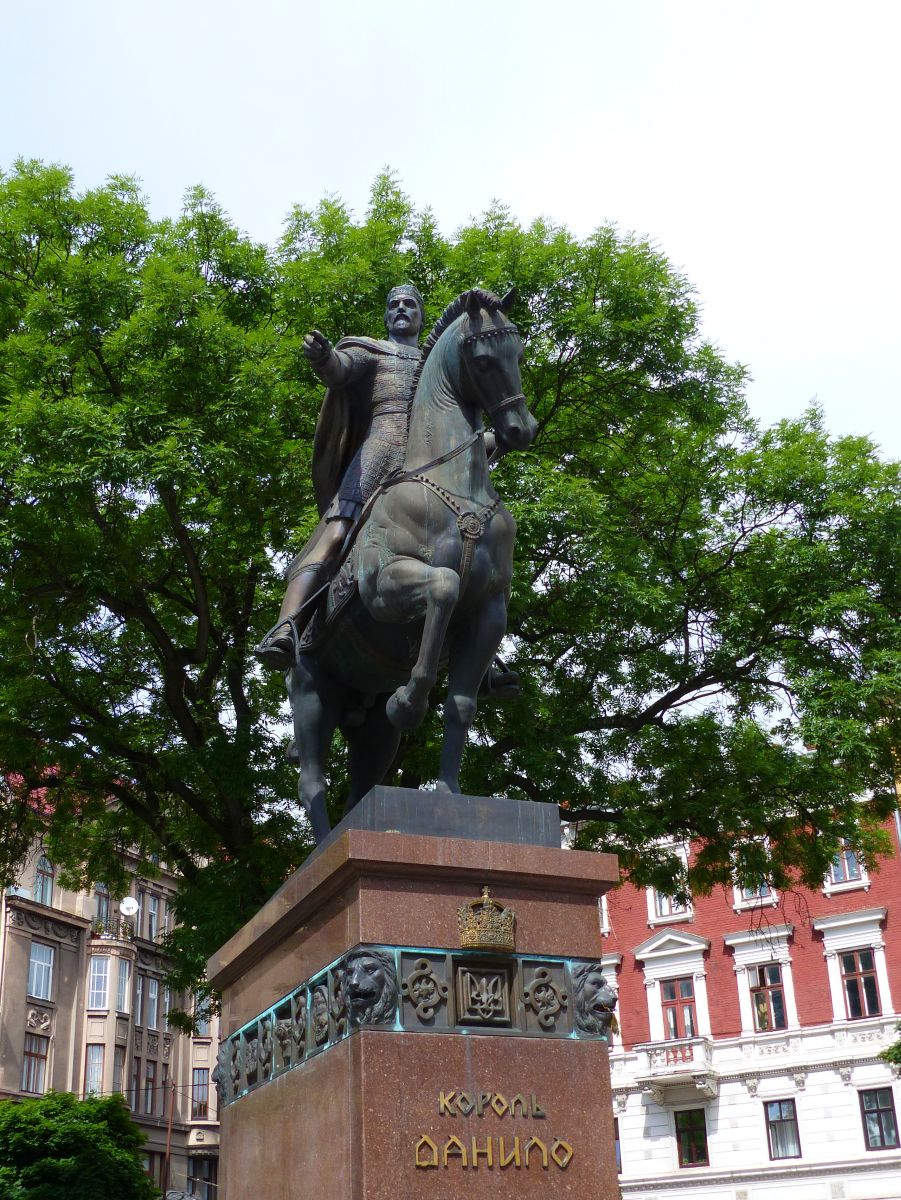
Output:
[{"xmin": 0, "ymin": 162, "xmax": 901, "ymax": 984}]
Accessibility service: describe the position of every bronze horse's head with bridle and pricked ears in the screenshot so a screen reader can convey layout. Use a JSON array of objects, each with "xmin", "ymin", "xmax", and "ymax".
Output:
[{"xmin": 461, "ymin": 288, "xmax": 537, "ymax": 450}]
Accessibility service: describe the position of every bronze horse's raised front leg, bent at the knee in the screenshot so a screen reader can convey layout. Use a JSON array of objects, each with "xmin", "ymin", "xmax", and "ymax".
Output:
[{"xmin": 371, "ymin": 558, "xmax": 459, "ymax": 730}]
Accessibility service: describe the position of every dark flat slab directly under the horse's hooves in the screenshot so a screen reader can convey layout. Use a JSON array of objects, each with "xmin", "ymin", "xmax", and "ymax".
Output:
[{"xmin": 307, "ymin": 785, "xmax": 560, "ymax": 862}]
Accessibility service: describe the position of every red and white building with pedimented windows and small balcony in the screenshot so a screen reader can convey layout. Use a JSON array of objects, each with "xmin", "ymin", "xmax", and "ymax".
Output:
[{"xmin": 601, "ymin": 820, "xmax": 901, "ymax": 1200}]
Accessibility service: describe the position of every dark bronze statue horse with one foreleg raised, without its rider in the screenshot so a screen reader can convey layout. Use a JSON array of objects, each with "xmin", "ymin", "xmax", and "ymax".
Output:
[{"xmin": 288, "ymin": 288, "xmax": 537, "ymax": 842}]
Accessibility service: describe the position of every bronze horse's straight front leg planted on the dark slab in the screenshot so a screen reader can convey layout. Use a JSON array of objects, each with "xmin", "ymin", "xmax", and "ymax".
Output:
[{"xmin": 438, "ymin": 593, "xmax": 506, "ymax": 792}]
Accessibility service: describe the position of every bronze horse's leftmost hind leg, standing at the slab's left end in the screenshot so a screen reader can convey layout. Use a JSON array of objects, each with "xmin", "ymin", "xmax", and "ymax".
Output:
[{"xmin": 288, "ymin": 660, "xmax": 338, "ymax": 846}]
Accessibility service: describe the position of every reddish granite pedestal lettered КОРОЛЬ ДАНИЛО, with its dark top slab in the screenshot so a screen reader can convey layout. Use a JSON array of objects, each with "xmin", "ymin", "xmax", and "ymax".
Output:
[{"xmin": 209, "ymin": 788, "xmax": 619, "ymax": 1200}]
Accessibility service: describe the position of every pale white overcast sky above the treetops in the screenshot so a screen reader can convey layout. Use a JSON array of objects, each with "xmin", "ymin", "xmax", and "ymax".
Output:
[{"xmin": 0, "ymin": 0, "xmax": 901, "ymax": 457}]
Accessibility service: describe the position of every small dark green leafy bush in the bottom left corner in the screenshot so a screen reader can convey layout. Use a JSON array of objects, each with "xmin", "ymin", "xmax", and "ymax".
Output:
[{"xmin": 0, "ymin": 1092, "xmax": 160, "ymax": 1200}]
